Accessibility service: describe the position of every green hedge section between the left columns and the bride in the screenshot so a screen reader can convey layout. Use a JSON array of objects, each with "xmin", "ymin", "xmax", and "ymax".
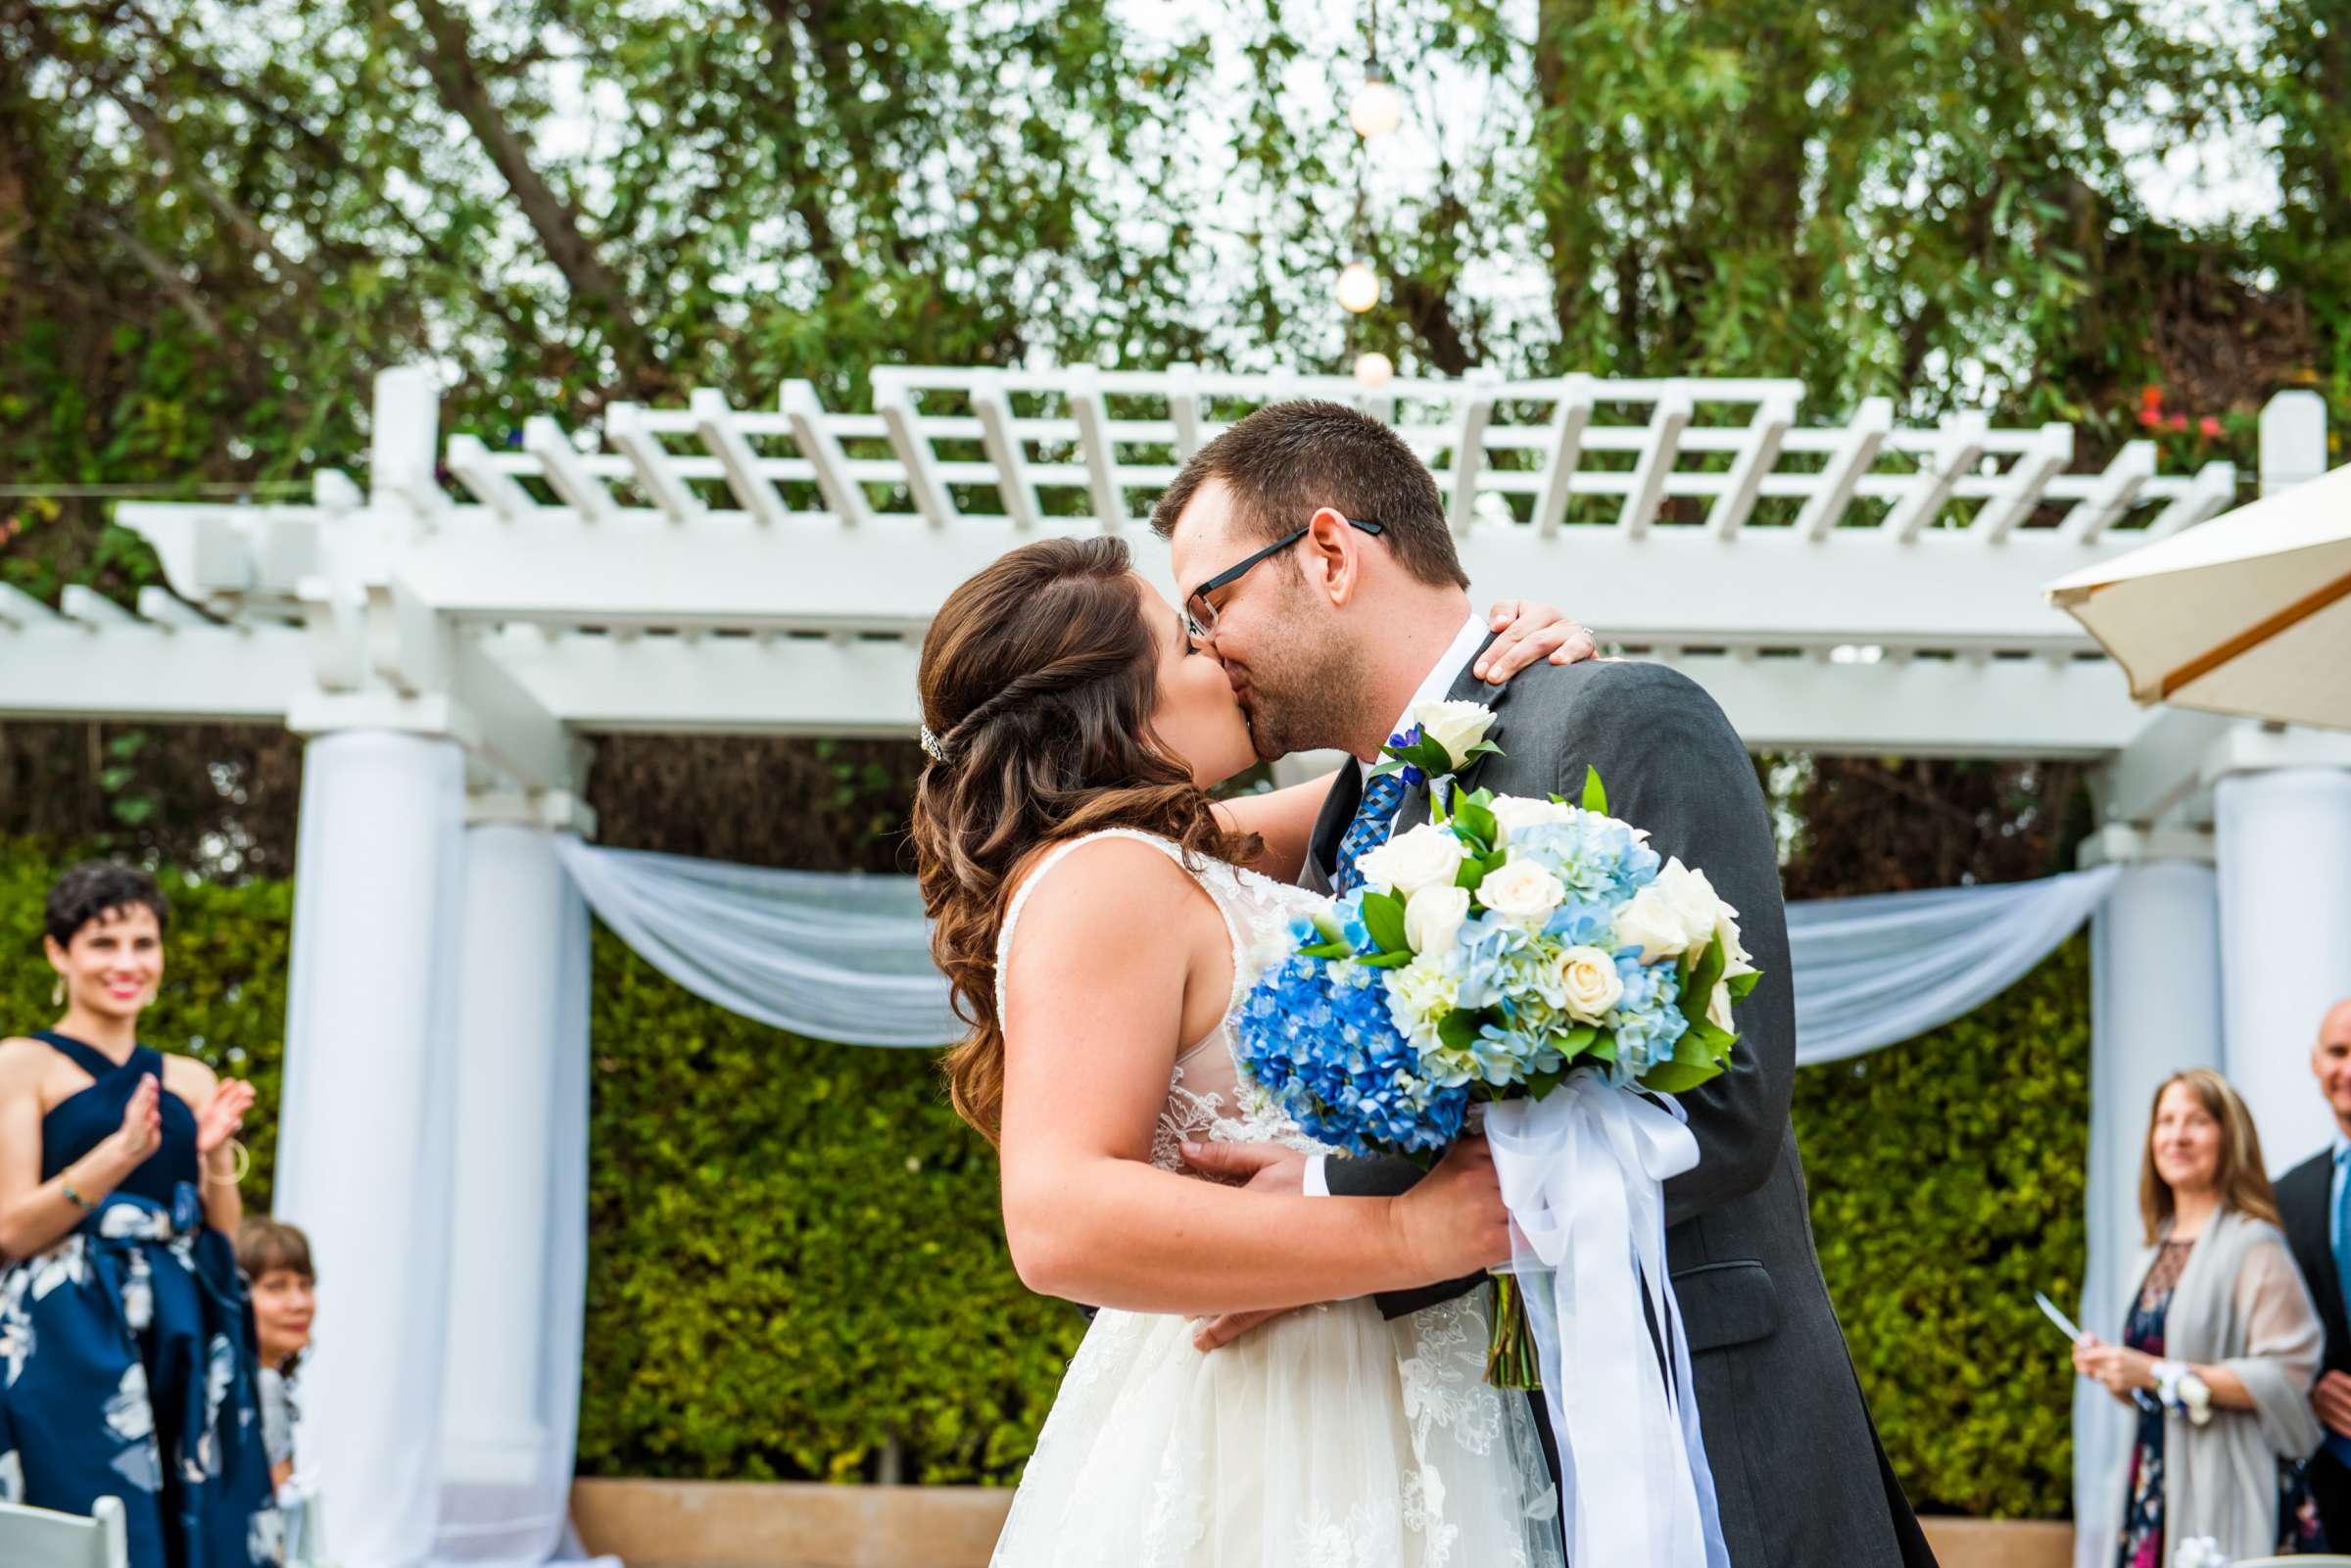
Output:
[{"xmin": 581, "ymin": 931, "xmax": 1083, "ymax": 1481}]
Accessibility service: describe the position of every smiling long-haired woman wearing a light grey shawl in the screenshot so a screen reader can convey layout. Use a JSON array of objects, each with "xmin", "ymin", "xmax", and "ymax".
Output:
[{"xmin": 2074, "ymin": 1068, "xmax": 2323, "ymax": 1568}]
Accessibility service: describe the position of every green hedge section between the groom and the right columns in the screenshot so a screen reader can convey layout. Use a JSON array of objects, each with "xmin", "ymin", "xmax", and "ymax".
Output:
[{"xmin": 1797, "ymin": 935, "xmax": 2090, "ymax": 1519}]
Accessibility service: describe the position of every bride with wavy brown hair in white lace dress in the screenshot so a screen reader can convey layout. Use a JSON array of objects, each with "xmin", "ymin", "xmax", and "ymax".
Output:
[{"xmin": 915, "ymin": 539, "xmax": 1561, "ymax": 1568}]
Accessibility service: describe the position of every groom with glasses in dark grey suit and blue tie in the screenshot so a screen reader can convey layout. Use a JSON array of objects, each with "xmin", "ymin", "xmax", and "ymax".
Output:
[{"xmin": 1152, "ymin": 402, "xmax": 1935, "ymax": 1568}]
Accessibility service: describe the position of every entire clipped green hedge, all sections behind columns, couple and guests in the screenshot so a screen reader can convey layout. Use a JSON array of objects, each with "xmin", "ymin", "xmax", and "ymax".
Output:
[{"xmin": 0, "ymin": 846, "xmax": 2090, "ymax": 1519}]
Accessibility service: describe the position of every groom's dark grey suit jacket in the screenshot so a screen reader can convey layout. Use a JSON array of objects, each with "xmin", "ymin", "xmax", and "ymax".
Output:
[{"xmin": 1303, "ymin": 660, "xmax": 1935, "ymax": 1568}]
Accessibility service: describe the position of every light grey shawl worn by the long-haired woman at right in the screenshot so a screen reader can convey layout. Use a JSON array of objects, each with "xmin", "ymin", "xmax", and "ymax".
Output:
[{"xmin": 2076, "ymin": 1209, "xmax": 2326, "ymax": 1563}]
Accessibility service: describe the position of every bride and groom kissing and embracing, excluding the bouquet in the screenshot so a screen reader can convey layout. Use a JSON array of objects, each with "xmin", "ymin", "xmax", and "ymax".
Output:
[{"xmin": 915, "ymin": 402, "xmax": 1933, "ymax": 1568}]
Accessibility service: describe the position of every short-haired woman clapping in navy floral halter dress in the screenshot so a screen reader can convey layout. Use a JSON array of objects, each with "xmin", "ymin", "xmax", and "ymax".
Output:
[{"xmin": 0, "ymin": 863, "xmax": 284, "ymax": 1568}]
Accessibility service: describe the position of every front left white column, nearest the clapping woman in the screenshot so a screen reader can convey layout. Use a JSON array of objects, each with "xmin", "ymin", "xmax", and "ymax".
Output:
[{"xmin": 277, "ymin": 731, "xmax": 465, "ymax": 1568}]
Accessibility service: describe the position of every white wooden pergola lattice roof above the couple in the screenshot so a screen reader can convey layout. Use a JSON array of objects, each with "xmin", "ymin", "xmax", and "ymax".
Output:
[{"xmin": 0, "ymin": 366, "xmax": 2235, "ymax": 783}]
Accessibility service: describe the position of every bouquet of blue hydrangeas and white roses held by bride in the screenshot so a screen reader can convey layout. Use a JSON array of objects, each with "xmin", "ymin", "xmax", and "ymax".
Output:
[{"xmin": 1239, "ymin": 703, "xmax": 1758, "ymax": 1387}]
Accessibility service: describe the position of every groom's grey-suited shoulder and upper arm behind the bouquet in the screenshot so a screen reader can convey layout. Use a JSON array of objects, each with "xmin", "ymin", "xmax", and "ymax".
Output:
[{"xmin": 1532, "ymin": 660, "xmax": 1797, "ymax": 1225}]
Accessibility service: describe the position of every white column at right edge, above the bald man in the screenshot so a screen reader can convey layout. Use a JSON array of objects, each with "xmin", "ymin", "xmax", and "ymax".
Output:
[{"xmin": 2215, "ymin": 766, "xmax": 2351, "ymax": 1173}]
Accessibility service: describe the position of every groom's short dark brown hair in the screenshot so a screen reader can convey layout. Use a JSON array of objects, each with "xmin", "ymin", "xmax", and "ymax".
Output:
[{"xmin": 1152, "ymin": 400, "xmax": 1469, "ymax": 588}]
